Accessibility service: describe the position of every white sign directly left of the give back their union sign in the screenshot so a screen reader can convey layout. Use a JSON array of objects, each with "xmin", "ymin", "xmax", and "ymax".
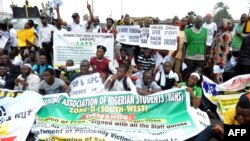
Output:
[{"xmin": 116, "ymin": 25, "xmax": 140, "ymax": 45}]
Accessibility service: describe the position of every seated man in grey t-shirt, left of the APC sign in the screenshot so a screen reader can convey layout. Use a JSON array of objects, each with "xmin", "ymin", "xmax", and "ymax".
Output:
[{"xmin": 39, "ymin": 68, "xmax": 70, "ymax": 95}]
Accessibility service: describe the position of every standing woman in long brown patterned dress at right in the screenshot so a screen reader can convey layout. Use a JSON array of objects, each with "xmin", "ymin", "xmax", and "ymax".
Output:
[{"xmin": 208, "ymin": 19, "xmax": 232, "ymax": 84}]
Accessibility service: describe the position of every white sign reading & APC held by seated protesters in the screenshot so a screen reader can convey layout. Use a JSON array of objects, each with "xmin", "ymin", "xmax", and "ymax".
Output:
[{"xmin": 70, "ymin": 73, "xmax": 104, "ymax": 96}]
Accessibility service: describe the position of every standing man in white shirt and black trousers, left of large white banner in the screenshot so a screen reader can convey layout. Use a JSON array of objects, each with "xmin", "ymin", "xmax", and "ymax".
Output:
[{"xmin": 40, "ymin": 14, "xmax": 56, "ymax": 65}]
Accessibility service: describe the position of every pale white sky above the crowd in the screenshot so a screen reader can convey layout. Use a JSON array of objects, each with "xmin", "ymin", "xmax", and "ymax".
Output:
[{"xmin": 2, "ymin": 0, "xmax": 250, "ymax": 22}]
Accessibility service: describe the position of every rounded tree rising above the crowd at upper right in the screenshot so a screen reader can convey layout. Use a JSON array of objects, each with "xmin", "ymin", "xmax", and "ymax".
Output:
[{"xmin": 214, "ymin": 2, "xmax": 232, "ymax": 25}]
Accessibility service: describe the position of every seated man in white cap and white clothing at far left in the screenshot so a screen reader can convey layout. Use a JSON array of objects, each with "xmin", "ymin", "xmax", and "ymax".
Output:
[{"xmin": 14, "ymin": 64, "xmax": 40, "ymax": 92}]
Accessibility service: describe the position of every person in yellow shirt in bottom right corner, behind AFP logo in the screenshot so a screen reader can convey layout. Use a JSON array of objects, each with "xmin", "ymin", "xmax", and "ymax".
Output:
[{"xmin": 194, "ymin": 92, "xmax": 250, "ymax": 141}]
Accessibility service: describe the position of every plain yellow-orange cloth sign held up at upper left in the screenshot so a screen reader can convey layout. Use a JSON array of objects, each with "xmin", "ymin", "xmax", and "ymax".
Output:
[{"xmin": 16, "ymin": 28, "xmax": 36, "ymax": 47}]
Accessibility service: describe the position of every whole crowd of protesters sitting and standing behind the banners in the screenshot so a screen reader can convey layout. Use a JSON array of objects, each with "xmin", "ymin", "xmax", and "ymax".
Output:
[{"xmin": 0, "ymin": 0, "xmax": 250, "ymax": 139}]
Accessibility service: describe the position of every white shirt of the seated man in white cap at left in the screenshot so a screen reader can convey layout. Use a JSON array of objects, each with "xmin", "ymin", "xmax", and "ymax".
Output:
[{"xmin": 14, "ymin": 73, "xmax": 40, "ymax": 92}]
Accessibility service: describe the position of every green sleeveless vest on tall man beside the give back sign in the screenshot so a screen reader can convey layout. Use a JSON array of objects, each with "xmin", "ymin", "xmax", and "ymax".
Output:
[{"xmin": 185, "ymin": 28, "xmax": 207, "ymax": 56}]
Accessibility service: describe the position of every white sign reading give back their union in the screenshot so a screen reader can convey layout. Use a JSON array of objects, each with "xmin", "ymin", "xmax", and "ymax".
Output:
[{"xmin": 147, "ymin": 25, "xmax": 179, "ymax": 50}]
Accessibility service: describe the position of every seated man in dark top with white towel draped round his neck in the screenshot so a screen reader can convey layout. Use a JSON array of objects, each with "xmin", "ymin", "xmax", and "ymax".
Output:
[{"xmin": 155, "ymin": 62, "xmax": 179, "ymax": 90}]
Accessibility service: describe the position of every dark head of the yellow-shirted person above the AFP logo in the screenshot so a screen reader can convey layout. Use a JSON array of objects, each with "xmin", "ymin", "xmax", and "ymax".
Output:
[{"xmin": 234, "ymin": 93, "xmax": 250, "ymax": 125}]
